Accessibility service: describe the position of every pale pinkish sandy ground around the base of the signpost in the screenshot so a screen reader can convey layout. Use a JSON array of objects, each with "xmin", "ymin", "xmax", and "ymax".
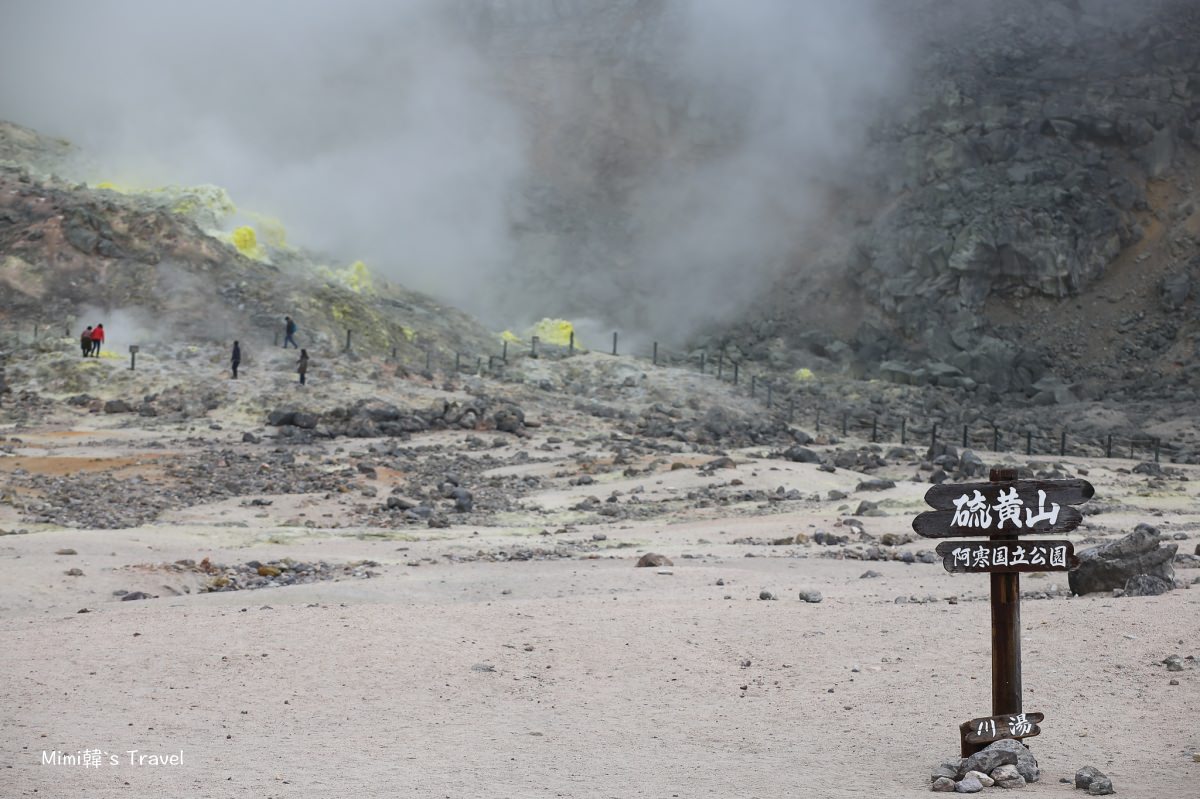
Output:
[{"xmin": 0, "ymin": 352, "xmax": 1200, "ymax": 799}]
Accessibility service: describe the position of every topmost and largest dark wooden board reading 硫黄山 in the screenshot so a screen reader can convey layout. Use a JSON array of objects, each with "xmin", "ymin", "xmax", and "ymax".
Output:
[{"xmin": 912, "ymin": 480, "xmax": 1094, "ymax": 539}]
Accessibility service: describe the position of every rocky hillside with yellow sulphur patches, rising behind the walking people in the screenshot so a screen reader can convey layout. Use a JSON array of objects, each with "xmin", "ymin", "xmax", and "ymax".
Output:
[{"xmin": 0, "ymin": 124, "xmax": 499, "ymax": 362}]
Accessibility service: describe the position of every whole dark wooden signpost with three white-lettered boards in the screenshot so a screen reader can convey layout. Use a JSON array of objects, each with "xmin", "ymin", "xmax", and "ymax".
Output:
[{"xmin": 912, "ymin": 469, "xmax": 1096, "ymax": 757}]
